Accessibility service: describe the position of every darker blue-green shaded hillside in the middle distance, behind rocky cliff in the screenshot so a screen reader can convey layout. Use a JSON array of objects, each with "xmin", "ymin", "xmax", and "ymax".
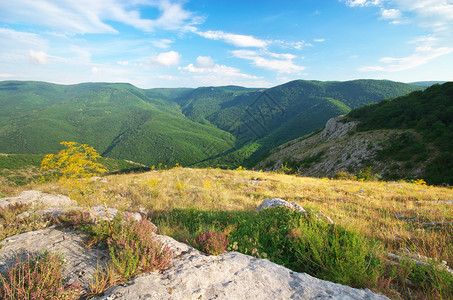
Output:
[{"xmin": 189, "ymin": 80, "xmax": 421, "ymax": 166}]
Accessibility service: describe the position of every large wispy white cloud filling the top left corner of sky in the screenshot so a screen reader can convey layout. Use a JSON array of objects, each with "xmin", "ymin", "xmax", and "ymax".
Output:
[{"xmin": 0, "ymin": 0, "xmax": 202, "ymax": 34}]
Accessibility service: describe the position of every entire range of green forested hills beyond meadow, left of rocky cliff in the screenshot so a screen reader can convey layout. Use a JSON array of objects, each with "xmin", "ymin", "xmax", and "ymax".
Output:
[{"xmin": 0, "ymin": 80, "xmax": 422, "ymax": 167}]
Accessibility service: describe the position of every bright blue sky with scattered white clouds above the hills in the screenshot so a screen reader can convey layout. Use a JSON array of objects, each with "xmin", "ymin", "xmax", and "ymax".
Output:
[{"xmin": 0, "ymin": 0, "xmax": 453, "ymax": 88}]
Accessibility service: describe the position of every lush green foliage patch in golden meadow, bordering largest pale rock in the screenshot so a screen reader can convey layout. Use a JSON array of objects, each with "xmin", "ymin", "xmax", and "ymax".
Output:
[{"xmin": 151, "ymin": 208, "xmax": 381, "ymax": 287}]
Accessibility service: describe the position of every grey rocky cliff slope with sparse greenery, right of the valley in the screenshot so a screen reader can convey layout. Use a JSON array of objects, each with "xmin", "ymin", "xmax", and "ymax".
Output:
[{"xmin": 255, "ymin": 116, "xmax": 425, "ymax": 178}]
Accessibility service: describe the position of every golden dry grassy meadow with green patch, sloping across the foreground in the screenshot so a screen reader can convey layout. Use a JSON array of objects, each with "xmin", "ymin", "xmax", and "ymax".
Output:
[{"xmin": 0, "ymin": 167, "xmax": 453, "ymax": 299}]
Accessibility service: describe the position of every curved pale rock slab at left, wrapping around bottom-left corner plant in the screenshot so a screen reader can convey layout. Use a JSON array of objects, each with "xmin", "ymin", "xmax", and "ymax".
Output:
[{"xmin": 0, "ymin": 228, "xmax": 108, "ymax": 288}]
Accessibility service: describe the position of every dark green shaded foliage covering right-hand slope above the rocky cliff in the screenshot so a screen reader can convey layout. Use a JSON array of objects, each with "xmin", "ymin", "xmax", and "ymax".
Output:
[{"xmin": 348, "ymin": 82, "xmax": 453, "ymax": 184}]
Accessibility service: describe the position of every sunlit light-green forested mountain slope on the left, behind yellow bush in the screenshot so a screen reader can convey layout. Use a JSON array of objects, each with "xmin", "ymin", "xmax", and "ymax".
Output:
[{"xmin": 0, "ymin": 82, "xmax": 233, "ymax": 165}]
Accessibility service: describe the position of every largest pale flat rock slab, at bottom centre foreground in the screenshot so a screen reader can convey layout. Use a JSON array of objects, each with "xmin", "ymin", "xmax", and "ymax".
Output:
[{"xmin": 96, "ymin": 237, "xmax": 388, "ymax": 300}]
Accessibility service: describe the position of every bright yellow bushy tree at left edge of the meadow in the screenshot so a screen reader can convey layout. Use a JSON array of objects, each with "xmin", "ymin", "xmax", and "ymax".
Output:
[{"xmin": 41, "ymin": 142, "xmax": 106, "ymax": 181}]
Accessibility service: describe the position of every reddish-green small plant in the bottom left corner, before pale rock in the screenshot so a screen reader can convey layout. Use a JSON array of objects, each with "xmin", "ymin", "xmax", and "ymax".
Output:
[{"xmin": 0, "ymin": 252, "xmax": 81, "ymax": 300}]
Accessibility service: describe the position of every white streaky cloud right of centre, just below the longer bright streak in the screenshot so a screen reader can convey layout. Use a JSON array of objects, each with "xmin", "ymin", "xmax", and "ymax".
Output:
[{"xmin": 232, "ymin": 50, "xmax": 305, "ymax": 74}]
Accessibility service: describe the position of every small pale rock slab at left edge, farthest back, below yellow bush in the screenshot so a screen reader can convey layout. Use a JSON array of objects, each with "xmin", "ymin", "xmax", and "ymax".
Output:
[{"xmin": 0, "ymin": 190, "xmax": 77, "ymax": 207}]
